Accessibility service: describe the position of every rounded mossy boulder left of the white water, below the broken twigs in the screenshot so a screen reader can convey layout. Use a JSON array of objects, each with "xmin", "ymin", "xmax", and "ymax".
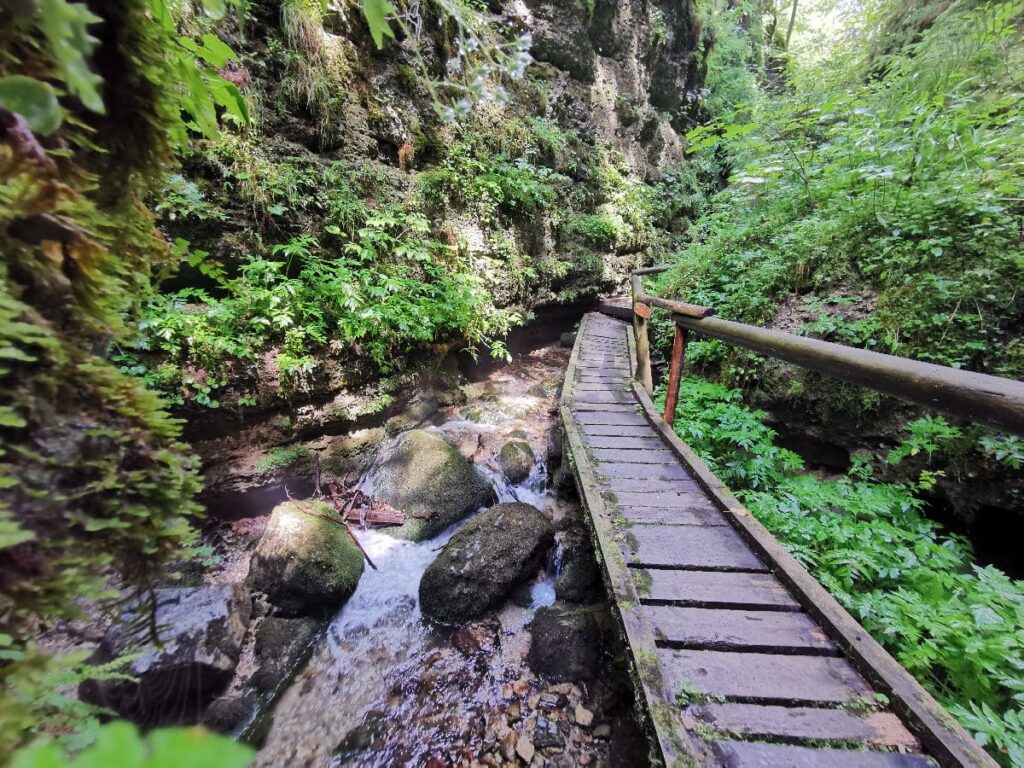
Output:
[{"xmin": 249, "ymin": 501, "xmax": 362, "ymax": 616}]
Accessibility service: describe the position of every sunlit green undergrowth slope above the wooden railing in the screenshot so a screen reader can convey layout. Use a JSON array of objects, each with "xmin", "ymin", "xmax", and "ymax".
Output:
[{"xmin": 656, "ymin": 0, "xmax": 1024, "ymax": 379}]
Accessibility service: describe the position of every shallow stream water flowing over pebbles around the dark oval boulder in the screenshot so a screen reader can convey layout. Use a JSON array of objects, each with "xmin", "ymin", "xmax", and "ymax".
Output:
[{"xmin": 257, "ymin": 347, "xmax": 635, "ymax": 768}]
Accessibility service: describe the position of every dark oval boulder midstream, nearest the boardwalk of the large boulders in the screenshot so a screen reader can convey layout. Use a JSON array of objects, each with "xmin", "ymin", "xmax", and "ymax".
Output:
[{"xmin": 420, "ymin": 503, "xmax": 554, "ymax": 624}]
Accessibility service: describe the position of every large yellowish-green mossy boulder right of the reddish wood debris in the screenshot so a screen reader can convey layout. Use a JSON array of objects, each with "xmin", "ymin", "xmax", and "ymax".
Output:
[{"xmin": 373, "ymin": 429, "xmax": 494, "ymax": 542}]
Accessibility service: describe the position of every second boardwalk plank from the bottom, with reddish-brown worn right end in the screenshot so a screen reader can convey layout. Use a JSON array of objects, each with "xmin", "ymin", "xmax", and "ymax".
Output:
[{"xmin": 686, "ymin": 703, "xmax": 921, "ymax": 751}]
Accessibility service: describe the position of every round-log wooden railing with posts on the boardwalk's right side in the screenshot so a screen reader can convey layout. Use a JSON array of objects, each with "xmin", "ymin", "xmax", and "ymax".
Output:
[{"xmin": 631, "ymin": 266, "xmax": 1024, "ymax": 436}]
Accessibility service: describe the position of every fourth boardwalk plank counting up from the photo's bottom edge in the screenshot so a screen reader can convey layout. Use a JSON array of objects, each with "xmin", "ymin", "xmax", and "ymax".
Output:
[{"xmin": 647, "ymin": 605, "xmax": 836, "ymax": 655}]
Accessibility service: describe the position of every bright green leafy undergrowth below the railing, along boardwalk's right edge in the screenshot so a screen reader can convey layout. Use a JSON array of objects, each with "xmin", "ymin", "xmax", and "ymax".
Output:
[{"xmin": 658, "ymin": 378, "xmax": 1024, "ymax": 765}]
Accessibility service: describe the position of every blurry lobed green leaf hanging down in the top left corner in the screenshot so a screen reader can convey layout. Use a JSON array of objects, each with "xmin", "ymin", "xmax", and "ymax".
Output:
[{"xmin": 39, "ymin": 0, "xmax": 104, "ymax": 115}]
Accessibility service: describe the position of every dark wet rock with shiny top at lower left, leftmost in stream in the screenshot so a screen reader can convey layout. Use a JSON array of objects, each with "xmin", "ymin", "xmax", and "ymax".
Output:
[{"xmin": 79, "ymin": 585, "xmax": 252, "ymax": 726}]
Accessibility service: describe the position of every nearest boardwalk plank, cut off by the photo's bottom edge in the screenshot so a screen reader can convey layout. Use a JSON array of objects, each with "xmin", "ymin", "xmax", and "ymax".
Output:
[{"xmin": 709, "ymin": 741, "xmax": 935, "ymax": 768}]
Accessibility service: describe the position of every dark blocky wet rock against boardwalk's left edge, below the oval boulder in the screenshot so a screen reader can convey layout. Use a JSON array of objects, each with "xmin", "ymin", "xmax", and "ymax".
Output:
[{"xmin": 527, "ymin": 603, "xmax": 604, "ymax": 682}]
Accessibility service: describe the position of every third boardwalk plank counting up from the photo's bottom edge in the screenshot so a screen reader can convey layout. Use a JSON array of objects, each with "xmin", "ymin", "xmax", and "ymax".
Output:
[{"xmin": 657, "ymin": 648, "xmax": 872, "ymax": 704}]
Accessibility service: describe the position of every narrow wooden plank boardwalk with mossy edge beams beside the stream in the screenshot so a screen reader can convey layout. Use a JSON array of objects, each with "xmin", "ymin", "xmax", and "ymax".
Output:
[{"xmin": 560, "ymin": 314, "xmax": 994, "ymax": 768}]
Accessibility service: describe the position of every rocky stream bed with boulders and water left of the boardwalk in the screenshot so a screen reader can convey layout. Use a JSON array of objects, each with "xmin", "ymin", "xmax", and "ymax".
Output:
[{"xmin": 66, "ymin": 333, "xmax": 646, "ymax": 768}]
